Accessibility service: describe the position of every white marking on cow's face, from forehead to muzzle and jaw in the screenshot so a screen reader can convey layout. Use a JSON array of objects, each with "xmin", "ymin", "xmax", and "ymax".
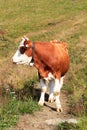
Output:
[{"xmin": 12, "ymin": 38, "xmax": 32, "ymax": 65}]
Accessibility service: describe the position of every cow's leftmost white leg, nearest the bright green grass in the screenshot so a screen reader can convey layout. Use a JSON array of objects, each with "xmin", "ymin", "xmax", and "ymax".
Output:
[{"xmin": 38, "ymin": 79, "xmax": 47, "ymax": 106}]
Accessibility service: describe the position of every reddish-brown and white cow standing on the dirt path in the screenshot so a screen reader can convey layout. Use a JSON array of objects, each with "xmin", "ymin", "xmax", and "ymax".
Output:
[{"xmin": 12, "ymin": 37, "xmax": 70, "ymax": 112}]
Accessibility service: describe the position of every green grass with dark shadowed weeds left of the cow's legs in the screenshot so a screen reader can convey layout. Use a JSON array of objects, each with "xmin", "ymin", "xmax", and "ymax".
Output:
[{"xmin": 0, "ymin": 80, "xmax": 41, "ymax": 130}]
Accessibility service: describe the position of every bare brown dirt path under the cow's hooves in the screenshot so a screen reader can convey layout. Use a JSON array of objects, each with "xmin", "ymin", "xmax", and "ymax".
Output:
[{"xmin": 10, "ymin": 91, "xmax": 76, "ymax": 130}]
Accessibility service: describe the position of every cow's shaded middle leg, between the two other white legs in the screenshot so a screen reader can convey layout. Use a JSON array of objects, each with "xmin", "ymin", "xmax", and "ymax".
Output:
[{"xmin": 48, "ymin": 79, "xmax": 55, "ymax": 102}]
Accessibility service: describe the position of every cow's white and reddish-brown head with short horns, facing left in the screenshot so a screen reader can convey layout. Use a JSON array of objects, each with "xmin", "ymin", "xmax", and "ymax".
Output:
[{"xmin": 12, "ymin": 37, "xmax": 32, "ymax": 65}]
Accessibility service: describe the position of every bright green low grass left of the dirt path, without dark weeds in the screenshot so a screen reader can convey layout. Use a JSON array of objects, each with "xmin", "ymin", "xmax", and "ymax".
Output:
[{"xmin": 0, "ymin": 98, "xmax": 40, "ymax": 130}]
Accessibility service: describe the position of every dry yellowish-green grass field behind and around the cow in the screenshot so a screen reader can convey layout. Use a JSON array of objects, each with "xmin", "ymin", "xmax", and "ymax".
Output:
[{"xmin": 0, "ymin": 0, "xmax": 87, "ymax": 130}]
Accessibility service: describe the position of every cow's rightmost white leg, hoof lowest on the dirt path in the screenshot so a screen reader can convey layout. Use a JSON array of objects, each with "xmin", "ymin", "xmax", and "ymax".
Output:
[{"xmin": 54, "ymin": 77, "xmax": 63, "ymax": 112}]
